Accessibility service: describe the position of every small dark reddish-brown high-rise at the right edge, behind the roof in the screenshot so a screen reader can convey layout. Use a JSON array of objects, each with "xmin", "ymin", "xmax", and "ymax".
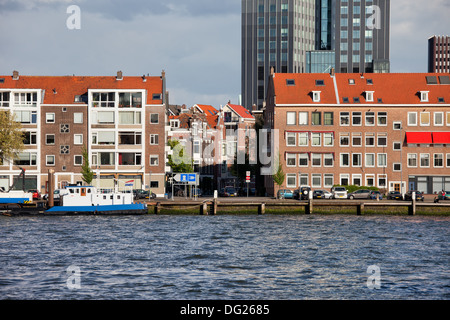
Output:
[{"xmin": 428, "ymin": 36, "xmax": 450, "ymax": 73}]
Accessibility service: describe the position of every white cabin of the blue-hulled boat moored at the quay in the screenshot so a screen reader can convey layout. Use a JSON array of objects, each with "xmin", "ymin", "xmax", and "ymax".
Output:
[{"xmin": 61, "ymin": 186, "xmax": 133, "ymax": 207}]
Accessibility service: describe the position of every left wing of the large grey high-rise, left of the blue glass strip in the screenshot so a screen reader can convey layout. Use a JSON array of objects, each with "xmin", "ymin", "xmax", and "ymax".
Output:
[{"xmin": 242, "ymin": 0, "xmax": 316, "ymax": 109}]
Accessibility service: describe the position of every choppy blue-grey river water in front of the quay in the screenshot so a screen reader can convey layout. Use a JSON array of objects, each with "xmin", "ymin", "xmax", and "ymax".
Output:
[{"xmin": 0, "ymin": 215, "xmax": 450, "ymax": 300}]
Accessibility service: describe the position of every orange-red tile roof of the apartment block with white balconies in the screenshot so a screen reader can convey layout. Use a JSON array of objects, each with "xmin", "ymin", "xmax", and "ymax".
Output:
[{"xmin": 0, "ymin": 75, "xmax": 163, "ymax": 105}]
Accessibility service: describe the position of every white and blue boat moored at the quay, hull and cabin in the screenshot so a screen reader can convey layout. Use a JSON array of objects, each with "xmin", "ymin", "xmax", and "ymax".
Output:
[{"xmin": 44, "ymin": 186, "xmax": 148, "ymax": 215}]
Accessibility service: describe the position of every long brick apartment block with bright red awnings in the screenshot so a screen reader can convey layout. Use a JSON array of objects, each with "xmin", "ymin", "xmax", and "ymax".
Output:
[{"xmin": 265, "ymin": 71, "xmax": 450, "ymax": 194}]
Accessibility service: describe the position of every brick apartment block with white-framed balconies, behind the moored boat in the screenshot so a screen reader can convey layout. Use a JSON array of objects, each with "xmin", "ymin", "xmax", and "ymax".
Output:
[{"xmin": 0, "ymin": 71, "xmax": 167, "ymax": 195}]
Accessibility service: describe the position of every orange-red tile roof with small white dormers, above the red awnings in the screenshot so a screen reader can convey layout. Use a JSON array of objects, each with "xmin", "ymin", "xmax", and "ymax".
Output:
[{"xmin": 274, "ymin": 73, "xmax": 450, "ymax": 104}]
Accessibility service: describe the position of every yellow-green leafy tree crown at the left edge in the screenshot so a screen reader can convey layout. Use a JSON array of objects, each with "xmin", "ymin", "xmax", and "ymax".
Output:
[{"xmin": 0, "ymin": 111, "xmax": 24, "ymax": 161}]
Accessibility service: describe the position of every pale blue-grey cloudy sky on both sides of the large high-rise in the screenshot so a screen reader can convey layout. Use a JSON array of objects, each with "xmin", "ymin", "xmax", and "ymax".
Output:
[{"xmin": 0, "ymin": 0, "xmax": 450, "ymax": 107}]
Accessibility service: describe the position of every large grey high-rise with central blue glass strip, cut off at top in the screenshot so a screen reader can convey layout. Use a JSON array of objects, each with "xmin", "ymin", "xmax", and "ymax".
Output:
[{"xmin": 242, "ymin": 0, "xmax": 390, "ymax": 109}]
